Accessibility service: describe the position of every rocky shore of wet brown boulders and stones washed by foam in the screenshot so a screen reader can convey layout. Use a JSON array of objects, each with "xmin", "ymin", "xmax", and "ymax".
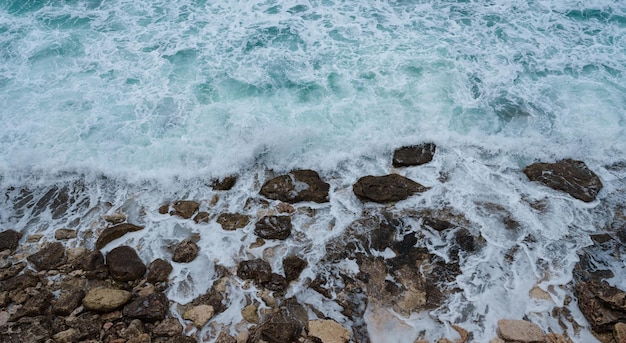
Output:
[{"xmin": 0, "ymin": 143, "xmax": 626, "ymax": 343}]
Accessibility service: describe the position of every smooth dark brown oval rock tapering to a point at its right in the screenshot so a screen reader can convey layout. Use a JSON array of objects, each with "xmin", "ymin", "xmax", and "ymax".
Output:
[{"xmin": 352, "ymin": 174, "xmax": 428, "ymax": 203}]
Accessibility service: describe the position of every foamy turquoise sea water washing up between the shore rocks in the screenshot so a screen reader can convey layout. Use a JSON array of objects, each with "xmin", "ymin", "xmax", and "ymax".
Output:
[{"xmin": 0, "ymin": 0, "xmax": 626, "ymax": 342}]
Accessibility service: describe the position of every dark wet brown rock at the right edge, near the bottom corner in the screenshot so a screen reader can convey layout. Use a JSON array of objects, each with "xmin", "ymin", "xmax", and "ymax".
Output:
[{"xmin": 575, "ymin": 281, "xmax": 626, "ymax": 332}]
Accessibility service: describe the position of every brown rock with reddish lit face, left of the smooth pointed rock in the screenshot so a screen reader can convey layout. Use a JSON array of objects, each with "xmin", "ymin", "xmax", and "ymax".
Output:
[{"xmin": 260, "ymin": 170, "xmax": 330, "ymax": 204}]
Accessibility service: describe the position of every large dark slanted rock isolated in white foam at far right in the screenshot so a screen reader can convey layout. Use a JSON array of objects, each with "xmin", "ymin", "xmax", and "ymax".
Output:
[{"xmin": 524, "ymin": 159, "xmax": 602, "ymax": 202}]
